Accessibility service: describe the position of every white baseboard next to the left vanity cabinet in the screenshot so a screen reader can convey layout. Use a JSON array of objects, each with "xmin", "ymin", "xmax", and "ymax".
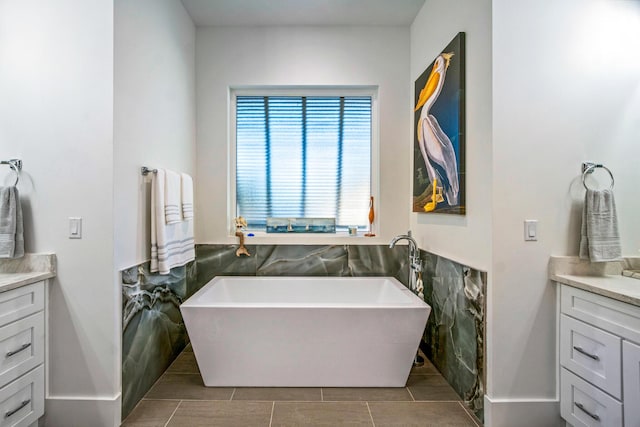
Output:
[{"xmin": 44, "ymin": 394, "xmax": 122, "ymax": 427}]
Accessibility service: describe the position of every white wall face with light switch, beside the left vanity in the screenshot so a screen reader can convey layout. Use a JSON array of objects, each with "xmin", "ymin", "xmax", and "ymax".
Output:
[{"xmin": 0, "ymin": 0, "xmax": 121, "ymax": 425}]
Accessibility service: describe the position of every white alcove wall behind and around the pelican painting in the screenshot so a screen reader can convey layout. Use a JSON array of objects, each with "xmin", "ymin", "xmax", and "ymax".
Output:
[{"xmin": 404, "ymin": 0, "xmax": 491, "ymax": 271}]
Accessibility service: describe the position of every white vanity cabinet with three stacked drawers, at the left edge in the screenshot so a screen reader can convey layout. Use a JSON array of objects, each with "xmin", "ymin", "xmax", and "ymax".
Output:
[{"xmin": 0, "ymin": 281, "xmax": 45, "ymax": 427}]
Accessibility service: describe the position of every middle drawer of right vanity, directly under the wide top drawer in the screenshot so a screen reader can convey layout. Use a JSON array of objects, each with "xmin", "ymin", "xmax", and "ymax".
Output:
[{"xmin": 560, "ymin": 314, "xmax": 622, "ymax": 399}]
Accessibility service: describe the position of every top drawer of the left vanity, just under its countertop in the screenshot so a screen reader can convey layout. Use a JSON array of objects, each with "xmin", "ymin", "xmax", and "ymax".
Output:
[{"xmin": 0, "ymin": 282, "xmax": 44, "ymax": 332}]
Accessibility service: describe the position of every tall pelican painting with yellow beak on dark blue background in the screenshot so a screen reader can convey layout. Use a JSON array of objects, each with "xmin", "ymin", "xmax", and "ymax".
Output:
[{"xmin": 413, "ymin": 33, "xmax": 465, "ymax": 214}]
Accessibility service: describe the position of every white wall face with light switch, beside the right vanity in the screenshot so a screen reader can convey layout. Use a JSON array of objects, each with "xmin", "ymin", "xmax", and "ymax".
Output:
[{"xmin": 488, "ymin": 0, "xmax": 640, "ymax": 420}]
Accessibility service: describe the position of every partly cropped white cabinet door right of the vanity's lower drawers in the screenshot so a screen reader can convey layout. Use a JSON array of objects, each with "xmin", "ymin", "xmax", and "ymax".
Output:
[{"xmin": 622, "ymin": 341, "xmax": 640, "ymax": 427}]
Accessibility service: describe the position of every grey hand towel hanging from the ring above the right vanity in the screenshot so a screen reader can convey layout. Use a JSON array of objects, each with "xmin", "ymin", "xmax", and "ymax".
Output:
[{"xmin": 580, "ymin": 189, "xmax": 622, "ymax": 262}]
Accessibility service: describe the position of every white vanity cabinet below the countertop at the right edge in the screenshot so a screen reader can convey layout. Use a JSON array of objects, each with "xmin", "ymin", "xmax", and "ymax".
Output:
[{"xmin": 559, "ymin": 282, "xmax": 640, "ymax": 427}]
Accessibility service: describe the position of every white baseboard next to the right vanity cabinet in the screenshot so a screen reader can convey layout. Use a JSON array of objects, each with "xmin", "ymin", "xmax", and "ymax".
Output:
[{"xmin": 484, "ymin": 395, "xmax": 565, "ymax": 427}]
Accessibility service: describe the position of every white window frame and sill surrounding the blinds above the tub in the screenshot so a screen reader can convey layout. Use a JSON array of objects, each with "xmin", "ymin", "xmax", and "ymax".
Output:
[{"xmin": 227, "ymin": 86, "xmax": 381, "ymax": 243}]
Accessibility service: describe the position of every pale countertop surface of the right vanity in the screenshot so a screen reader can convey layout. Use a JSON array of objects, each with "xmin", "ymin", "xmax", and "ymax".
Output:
[{"xmin": 550, "ymin": 274, "xmax": 640, "ymax": 307}]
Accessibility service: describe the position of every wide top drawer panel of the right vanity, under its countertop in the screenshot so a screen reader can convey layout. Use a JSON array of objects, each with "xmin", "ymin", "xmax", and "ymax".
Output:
[{"xmin": 560, "ymin": 286, "xmax": 640, "ymax": 344}]
